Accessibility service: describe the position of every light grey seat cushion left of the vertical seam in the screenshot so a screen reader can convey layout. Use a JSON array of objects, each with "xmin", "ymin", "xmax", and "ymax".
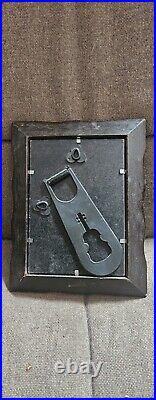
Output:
[{"xmin": 3, "ymin": 242, "xmax": 92, "ymax": 398}]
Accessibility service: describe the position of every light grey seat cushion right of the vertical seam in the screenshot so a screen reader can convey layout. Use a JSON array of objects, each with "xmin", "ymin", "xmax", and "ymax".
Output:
[{"xmin": 88, "ymin": 240, "xmax": 153, "ymax": 398}]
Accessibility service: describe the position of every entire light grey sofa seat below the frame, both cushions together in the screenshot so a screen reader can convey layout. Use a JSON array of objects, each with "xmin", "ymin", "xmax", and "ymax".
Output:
[{"xmin": 3, "ymin": 239, "xmax": 153, "ymax": 398}]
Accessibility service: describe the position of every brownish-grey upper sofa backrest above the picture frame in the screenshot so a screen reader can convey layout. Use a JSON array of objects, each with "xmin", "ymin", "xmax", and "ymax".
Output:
[{"xmin": 3, "ymin": 2, "xmax": 153, "ymax": 138}]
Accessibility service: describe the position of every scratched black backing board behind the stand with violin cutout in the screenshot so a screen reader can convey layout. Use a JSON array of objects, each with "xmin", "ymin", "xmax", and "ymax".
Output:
[{"xmin": 28, "ymin": 138, "xmax": 125, "ymax": 276}]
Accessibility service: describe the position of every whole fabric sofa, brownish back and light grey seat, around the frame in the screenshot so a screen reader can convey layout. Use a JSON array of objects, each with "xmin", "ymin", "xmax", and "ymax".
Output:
[{"xmin": 3, "ymin": 2, "xmax": 153, "ymax": 398}]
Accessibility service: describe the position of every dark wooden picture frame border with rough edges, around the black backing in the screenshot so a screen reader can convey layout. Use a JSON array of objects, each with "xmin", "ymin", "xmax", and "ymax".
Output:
[{"xmin": 10, "ymin": 119, "xmax": 147, "ymax": 297}]
